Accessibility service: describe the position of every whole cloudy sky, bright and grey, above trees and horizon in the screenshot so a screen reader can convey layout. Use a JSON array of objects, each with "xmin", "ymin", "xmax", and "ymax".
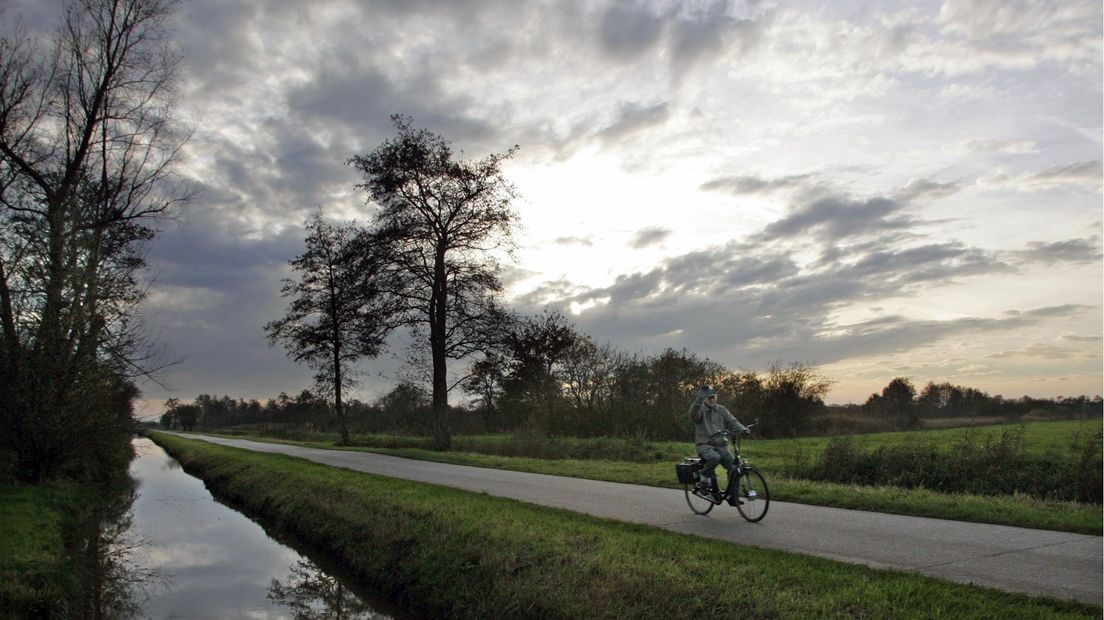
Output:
[{"xmin": 9, "ymin": 0, "xmax": 1104, "ymax": 414}]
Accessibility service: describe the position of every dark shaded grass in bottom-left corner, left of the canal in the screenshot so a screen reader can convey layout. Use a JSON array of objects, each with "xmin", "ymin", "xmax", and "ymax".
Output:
[{"xmin": 0, "ymin": 484, "xmax": 87, "ymax": 618}]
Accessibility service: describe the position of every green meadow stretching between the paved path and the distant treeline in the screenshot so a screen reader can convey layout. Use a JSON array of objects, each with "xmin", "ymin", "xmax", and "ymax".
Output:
[{"xmin": 208, "ymin": 419, "xmax": 1104, "ymax": 535}]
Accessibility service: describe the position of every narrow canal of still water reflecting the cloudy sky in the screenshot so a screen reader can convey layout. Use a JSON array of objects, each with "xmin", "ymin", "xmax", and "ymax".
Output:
[{"xmin": 119, "ymin": 438, "xmax": 404, "ymax": 619}]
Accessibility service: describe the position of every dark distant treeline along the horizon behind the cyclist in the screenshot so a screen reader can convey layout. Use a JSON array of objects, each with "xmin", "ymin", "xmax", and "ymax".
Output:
[{"xmin": 160, "ymin": 333, "xmax": 1102, "ymax": 440}]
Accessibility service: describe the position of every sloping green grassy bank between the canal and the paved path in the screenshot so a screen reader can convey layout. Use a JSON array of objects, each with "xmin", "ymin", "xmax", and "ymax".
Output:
[{"xmin": 155, "ymin": 435, "xmax": 1101, "ymax": 619}]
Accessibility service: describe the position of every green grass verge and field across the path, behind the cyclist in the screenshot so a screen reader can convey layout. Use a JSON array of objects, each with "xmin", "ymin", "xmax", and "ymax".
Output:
[{"xmin": 194, "ymin": 420, "xmax": 1104, "ymax": 535}]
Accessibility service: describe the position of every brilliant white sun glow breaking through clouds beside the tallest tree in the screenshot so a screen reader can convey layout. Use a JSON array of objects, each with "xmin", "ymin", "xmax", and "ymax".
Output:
[{"xmin": 507, "ymin": 145, "xmax": 781, "ymax": 297}]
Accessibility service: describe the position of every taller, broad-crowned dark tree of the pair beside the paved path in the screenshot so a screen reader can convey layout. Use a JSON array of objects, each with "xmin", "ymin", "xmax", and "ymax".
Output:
[{"xmin": 349, "ymin": 116, "xmax": 517, "ymax": 449}]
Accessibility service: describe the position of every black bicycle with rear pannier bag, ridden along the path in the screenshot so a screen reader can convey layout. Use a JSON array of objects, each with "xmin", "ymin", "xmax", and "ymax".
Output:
[{"xmin": 675, "ymin": 420, "xmax": 771, "ymax": 523}]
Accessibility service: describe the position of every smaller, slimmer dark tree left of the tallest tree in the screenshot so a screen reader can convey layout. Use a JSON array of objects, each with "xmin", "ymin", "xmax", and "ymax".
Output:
[{"xmin": 265, "ymin": 213, "xmax": 393, "ymax": 445}]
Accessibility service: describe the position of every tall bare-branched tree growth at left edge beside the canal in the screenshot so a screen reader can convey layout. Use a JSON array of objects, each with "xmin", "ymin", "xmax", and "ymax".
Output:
[{"xmin": 0, "ymin": 0, "xmax": 187, "ymax": 478}]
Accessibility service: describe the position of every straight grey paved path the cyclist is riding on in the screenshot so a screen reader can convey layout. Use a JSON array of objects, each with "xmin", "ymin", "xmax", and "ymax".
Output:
[{"xmin": 165, "ymin": 435, "xmax": 1102, "ymax": 605}]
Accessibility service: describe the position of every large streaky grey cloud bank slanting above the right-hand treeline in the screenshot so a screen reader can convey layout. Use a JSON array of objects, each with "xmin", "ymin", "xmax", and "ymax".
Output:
[{"xmin": 522, "ymin": 188, "xmax": 1091, "ymax": 364}]
